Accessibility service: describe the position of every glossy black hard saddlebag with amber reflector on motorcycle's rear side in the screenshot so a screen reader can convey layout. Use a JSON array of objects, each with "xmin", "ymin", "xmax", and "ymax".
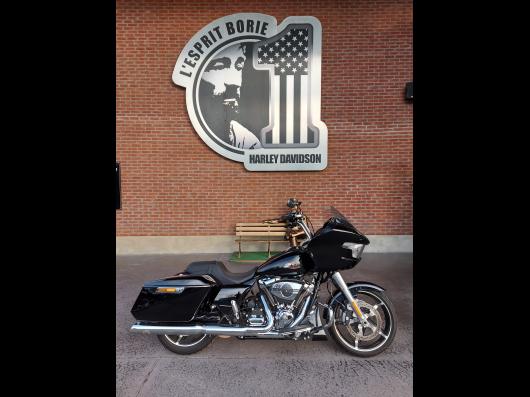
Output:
[{"xmin": 131, "ymin": 274, "xmax": 215, "ymax": 322}]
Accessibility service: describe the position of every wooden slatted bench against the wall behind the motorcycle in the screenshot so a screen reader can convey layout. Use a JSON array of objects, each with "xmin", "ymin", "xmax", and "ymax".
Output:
[{"xmin": 236, "ymin": 223, "xmax": 289, "ymax": 258}]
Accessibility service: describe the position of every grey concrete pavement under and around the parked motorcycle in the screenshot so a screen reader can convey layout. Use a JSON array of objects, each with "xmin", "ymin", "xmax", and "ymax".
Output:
[{"xmin": 116, "ymin": 253, "xmax": 413, "ymax": 397}]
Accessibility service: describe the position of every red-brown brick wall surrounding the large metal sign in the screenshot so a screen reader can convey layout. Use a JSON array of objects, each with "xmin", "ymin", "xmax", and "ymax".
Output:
[{"xmin": 116, "ymin": 0, "xmax": 412, "ymax": 236}]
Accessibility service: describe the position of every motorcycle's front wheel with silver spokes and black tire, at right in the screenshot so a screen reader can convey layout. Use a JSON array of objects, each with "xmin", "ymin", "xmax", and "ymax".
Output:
[{"xmin": 329, "ymin": 289, "xmax": 396, "ymax": 357}]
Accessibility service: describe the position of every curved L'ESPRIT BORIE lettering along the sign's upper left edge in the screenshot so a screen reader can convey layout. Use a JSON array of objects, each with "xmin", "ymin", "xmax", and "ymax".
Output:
[{"xmin": 180, "ymin": 19, "xmax": 269, "ymax": 77}]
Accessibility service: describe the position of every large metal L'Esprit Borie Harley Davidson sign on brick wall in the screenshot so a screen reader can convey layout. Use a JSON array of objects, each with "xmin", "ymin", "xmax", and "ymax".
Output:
[{"xmin": 173, "ymin": 13, "xmax": 328, "ymax": 171}]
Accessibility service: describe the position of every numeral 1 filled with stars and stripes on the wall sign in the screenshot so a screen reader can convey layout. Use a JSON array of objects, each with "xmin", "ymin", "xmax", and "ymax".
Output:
[{"xmin": 257, "ymin": 28, "xmax": 315, "ymax": 145}]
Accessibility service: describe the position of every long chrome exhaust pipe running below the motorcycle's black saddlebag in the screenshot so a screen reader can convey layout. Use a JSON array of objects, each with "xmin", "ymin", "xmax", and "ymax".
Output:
[{"xmin": 131, "ymin": 294, "xmax": 274, "ymax": 336}]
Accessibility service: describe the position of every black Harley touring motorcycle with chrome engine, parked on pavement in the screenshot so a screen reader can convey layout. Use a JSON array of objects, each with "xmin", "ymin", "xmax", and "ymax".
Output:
[{"xmin": 131, "ymin": 199, "xmax": 396, "ymax": 357}]
